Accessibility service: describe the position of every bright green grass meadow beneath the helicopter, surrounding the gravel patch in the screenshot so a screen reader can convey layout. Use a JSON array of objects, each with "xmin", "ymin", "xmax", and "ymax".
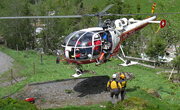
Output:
[{"xmin": 0, "ymin": 48, "xmax": 180, "ymax": 109}]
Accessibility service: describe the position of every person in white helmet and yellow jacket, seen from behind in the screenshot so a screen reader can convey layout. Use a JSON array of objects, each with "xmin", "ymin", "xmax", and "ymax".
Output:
[{"xmin": 107, "ymin": 74, "xmax": 122, "ymax": 103}]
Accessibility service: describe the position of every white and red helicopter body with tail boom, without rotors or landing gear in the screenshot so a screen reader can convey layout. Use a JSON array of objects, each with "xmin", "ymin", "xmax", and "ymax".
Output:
[{"xmin": 62, "ymin": 16, "xmax": 156, "ymax": 64}]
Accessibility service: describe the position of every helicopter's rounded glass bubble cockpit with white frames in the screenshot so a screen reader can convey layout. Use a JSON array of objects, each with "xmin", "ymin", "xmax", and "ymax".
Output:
[{"xmin": 62, "ymin": 31, "xmax": 112, "ymax": 60}]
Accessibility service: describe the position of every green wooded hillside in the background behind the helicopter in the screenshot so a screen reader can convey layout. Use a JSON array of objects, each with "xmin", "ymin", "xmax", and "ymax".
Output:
[{"xmin": 0, "ymin": 0, "xmax": 180, "ymax": 57}]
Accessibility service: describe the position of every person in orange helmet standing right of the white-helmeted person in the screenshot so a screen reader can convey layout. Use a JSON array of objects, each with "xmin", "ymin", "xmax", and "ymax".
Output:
[{"xmin": 119, "ymin": 74, "xmax": 127, "ymax": 101}]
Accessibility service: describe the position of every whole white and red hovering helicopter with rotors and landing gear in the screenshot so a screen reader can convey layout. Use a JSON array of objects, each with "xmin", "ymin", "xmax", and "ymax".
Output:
[{"xmin": 0, "ymin": 3, "xmax": 180, "ymax": 77}]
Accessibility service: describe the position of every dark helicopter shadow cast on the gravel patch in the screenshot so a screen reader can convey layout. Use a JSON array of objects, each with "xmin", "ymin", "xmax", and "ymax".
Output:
[{"xmin": 74, "ymin": 76, "xmax": 110, "ymax": 97}]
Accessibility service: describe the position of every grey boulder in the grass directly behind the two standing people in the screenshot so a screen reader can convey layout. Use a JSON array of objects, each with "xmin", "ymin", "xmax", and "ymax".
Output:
[{"xmin": 116, "ymin": 72, "xmax": 135, "ymax": 81}]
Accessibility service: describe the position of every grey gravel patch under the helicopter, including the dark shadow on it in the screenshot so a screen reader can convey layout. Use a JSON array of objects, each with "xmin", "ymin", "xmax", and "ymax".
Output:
[{"xmin": 11, "ymin": 76, "xmax": 110, "ymax": 109}]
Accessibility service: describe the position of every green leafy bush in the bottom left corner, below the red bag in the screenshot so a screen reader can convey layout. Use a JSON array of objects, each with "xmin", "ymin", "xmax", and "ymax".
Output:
[{"xmin": 0, "ymin": 97, "xmax": 38, "ymax": 110}]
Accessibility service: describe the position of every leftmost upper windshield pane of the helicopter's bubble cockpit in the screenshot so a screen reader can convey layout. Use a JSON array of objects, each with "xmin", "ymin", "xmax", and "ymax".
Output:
[{"xmin": 68, "ymin": 31, "xmax": 85, "ymax": 46}]
